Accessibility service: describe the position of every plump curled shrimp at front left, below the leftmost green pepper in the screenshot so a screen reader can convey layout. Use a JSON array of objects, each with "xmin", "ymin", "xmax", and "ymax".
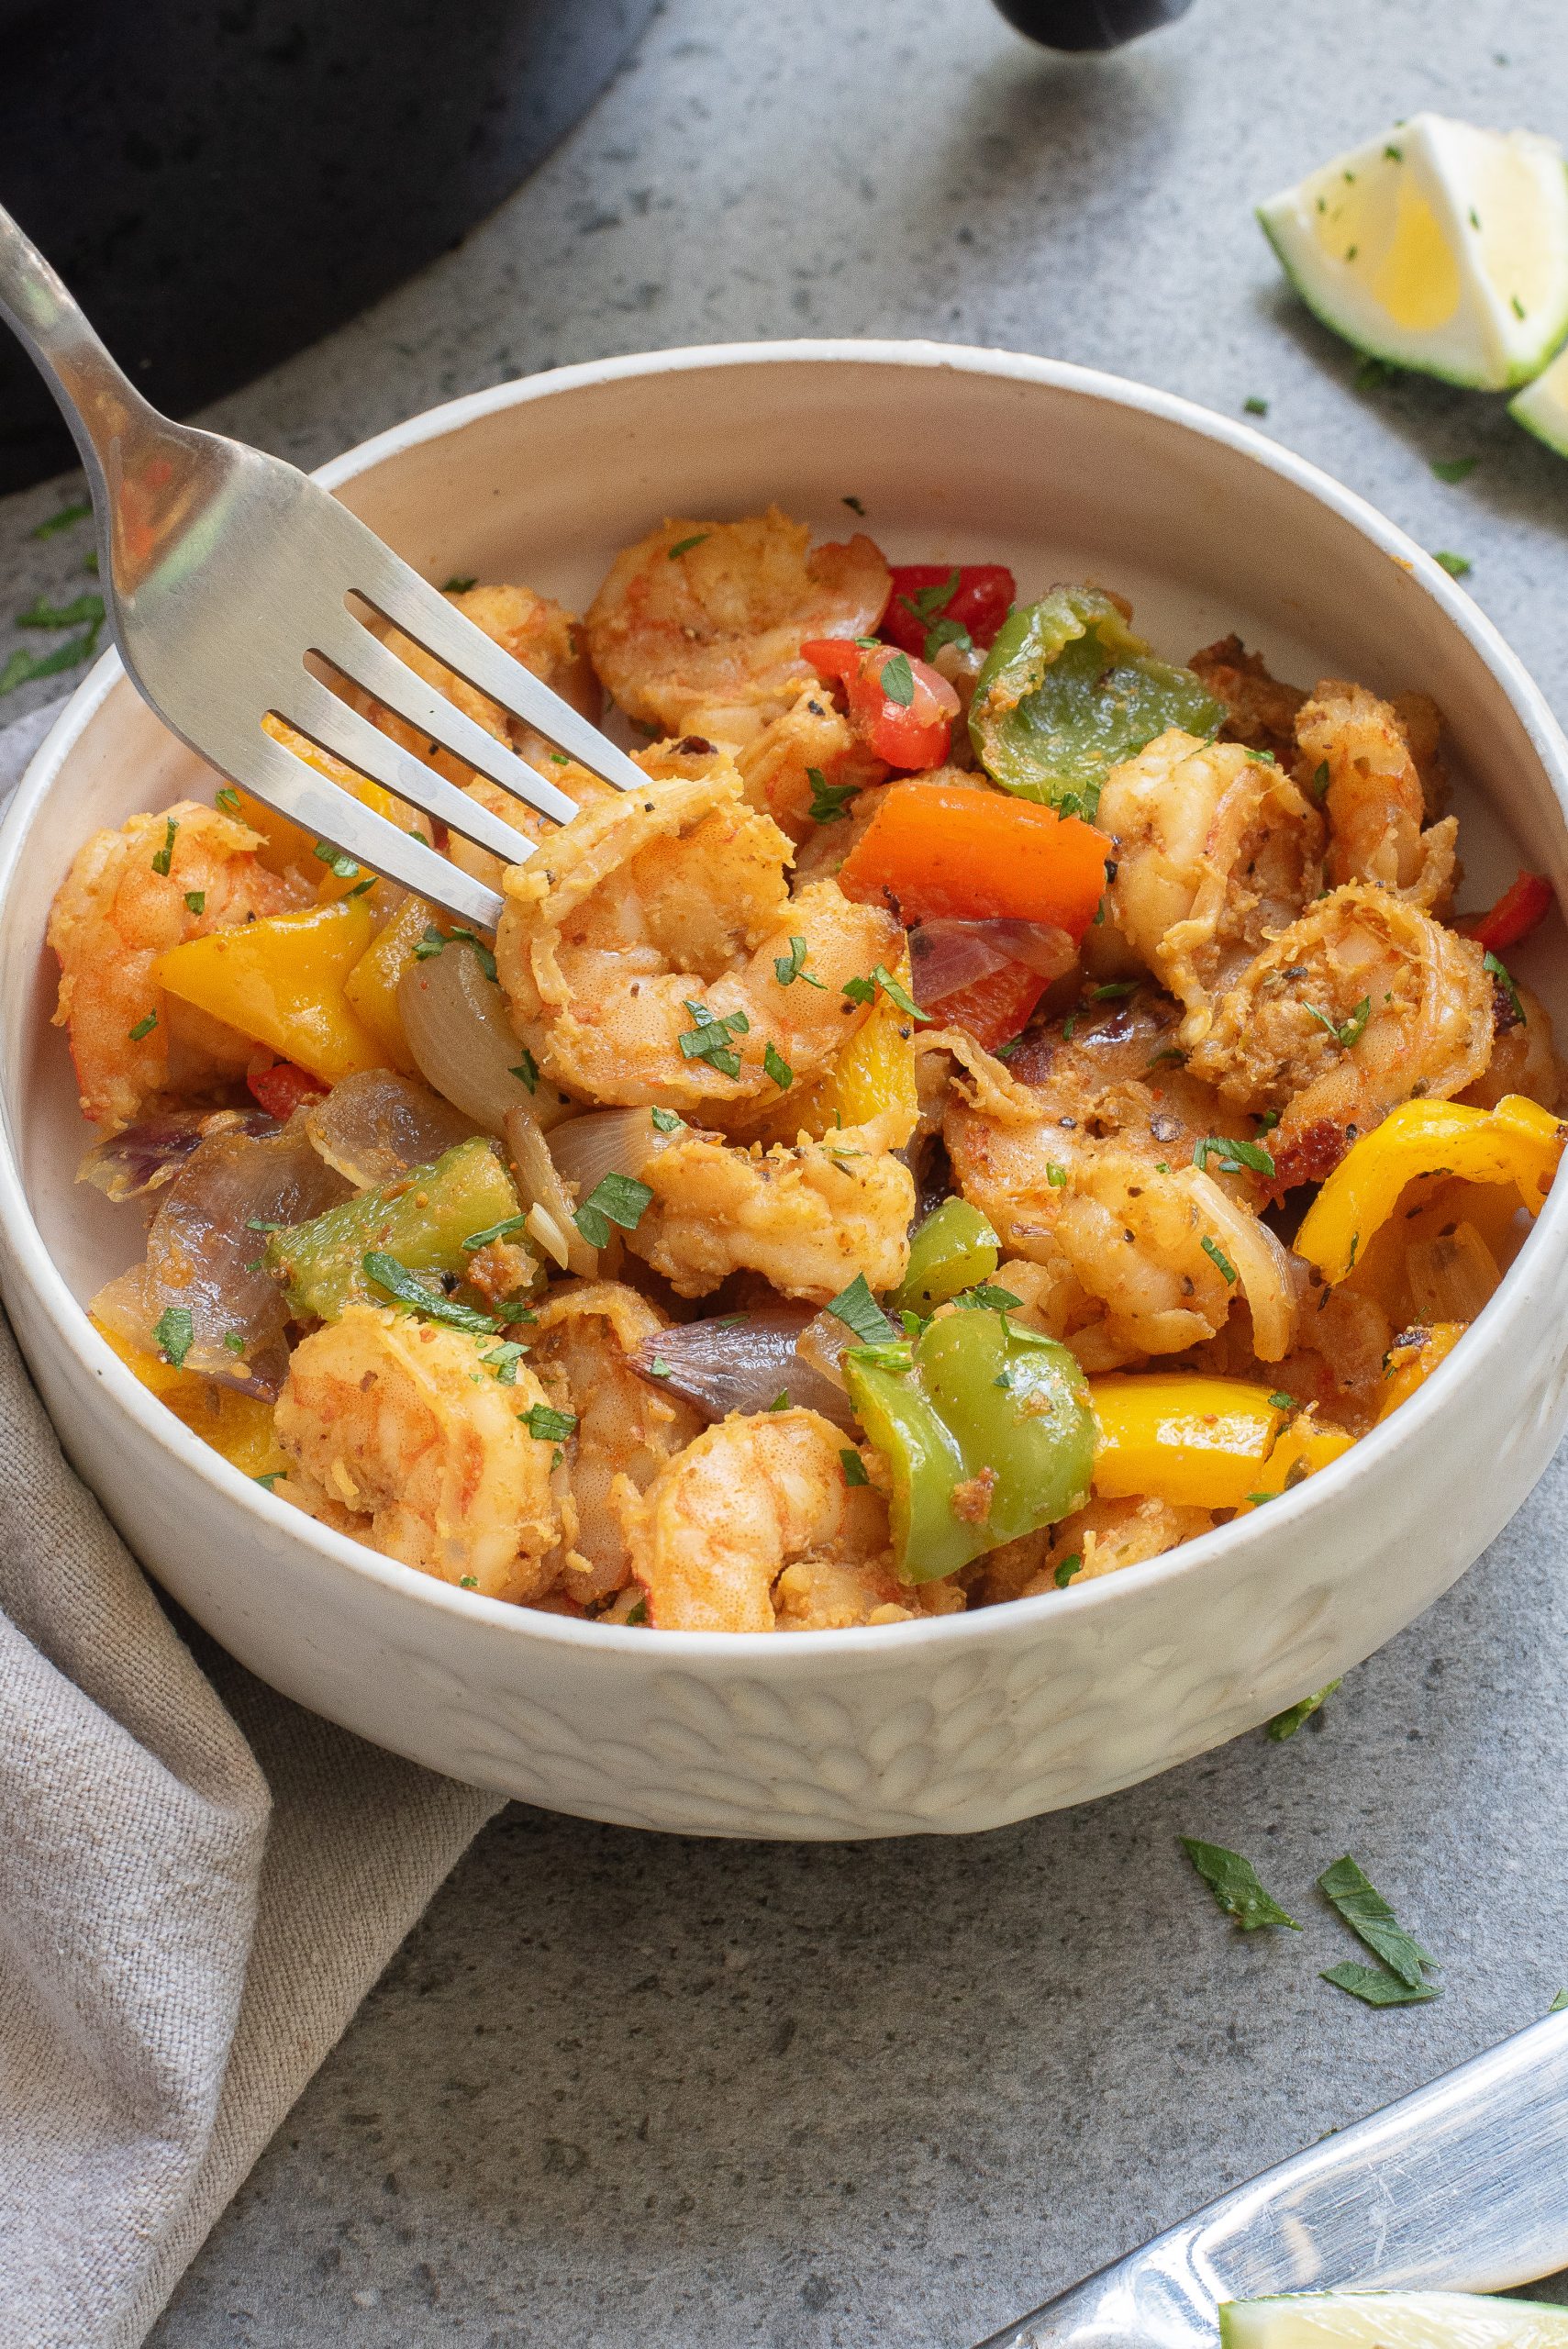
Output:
[{"xmin": 274, "ymin": 1306, "xmax": 561, "ymax": 1599}]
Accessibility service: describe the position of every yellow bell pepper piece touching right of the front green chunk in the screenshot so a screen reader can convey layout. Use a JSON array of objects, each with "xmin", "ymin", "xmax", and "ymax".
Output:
[{"xmin": 1089, "ymin": 1369, "xmax": 1289, "ymax": 1508}]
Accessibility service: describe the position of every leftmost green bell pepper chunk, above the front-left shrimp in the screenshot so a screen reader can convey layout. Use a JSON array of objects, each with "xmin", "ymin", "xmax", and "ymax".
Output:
[{"xmin": 265, "ymin": 1134, "xmax": 521, "ymax": 1320}]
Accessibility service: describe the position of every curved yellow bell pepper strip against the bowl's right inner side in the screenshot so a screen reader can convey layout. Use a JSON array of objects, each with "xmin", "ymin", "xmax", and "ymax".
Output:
[{"xmin": 1296, "ymin": 1092, "xmax": 1568, "ymax": 1283}]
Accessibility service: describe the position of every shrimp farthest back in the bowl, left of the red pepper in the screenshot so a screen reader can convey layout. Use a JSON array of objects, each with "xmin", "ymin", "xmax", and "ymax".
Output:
[{"xmin": 584, "ymin": 505, "xmax": 892, "ymax": 745}]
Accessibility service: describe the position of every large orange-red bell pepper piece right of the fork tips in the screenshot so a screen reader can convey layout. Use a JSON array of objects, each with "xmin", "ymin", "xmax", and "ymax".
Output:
[{"xmin": 838, "ymin": 782, "xmax": 1110, "ymax": 940}]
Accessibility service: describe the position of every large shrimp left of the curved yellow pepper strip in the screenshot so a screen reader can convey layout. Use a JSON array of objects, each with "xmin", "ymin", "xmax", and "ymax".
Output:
[{"xmin": 943, "ymin": 998, "xmax": 1296, "ymax": 1369}]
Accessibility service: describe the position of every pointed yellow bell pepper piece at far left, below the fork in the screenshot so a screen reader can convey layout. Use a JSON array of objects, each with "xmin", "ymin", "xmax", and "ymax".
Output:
[{"xmin": 152, "ymin": 897, "xmax": 383, "ymax": 1085}]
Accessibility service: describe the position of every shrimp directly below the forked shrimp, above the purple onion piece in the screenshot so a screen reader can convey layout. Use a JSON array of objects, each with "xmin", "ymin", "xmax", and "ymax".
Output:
[{"xmin": 627, "ymin": 1111, "xmax": 916, "ymax": 1304}]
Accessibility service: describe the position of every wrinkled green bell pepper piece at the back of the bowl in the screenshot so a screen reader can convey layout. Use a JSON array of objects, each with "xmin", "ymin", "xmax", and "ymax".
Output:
[{"xmin": 970, "ymin": 587, "xmax": 1225, "ymax": 822}]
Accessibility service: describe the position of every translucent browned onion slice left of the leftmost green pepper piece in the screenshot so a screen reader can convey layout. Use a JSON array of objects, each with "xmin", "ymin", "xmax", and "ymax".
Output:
[{"xmin": 92, "ymin": 1116, "xmax": 352, "ymax": 1402}]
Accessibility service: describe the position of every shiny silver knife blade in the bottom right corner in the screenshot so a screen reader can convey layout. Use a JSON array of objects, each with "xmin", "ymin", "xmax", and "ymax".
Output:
[{"xmin": 979, "ymin": 2013, "xmax": 1568, "ymax": 2349}]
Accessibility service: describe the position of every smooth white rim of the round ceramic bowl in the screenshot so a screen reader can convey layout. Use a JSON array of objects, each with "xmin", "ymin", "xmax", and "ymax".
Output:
[{"xmin": 0, "ymin": 339, "xmax": 1568, "ymax": 1673}]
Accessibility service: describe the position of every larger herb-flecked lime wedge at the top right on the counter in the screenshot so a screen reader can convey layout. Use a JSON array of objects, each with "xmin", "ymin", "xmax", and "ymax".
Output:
[{"xmin": 1258, "ymin": 115, "xmax": 1568, "ymax": 393}]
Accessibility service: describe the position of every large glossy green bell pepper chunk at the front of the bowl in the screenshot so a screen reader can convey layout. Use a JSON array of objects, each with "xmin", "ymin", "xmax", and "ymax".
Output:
[{"xmin": 845, "ymin": 1308, "xmax": 1094, "ymax": 1583}]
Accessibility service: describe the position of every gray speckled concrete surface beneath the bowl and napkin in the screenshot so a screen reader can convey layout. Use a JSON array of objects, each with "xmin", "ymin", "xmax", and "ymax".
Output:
[{"xmin": 0, "ymin": 0, "xmax": 1568, "ymax": 2349}]
